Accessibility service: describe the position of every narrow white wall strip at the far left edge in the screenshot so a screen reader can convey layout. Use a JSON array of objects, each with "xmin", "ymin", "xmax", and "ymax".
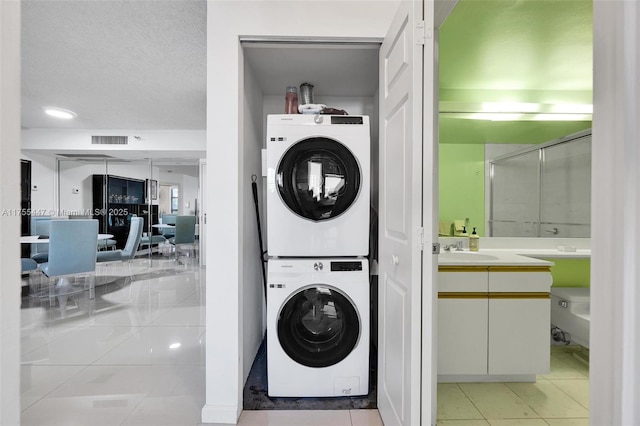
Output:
[{"xmin": 0, "ymin": 1, "xmax": 20, "ymax": 425}]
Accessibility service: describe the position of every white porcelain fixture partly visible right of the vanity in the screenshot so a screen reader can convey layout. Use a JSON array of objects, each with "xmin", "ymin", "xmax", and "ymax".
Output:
[{"xmin": 551, "ymin": 287, "xmax": 590, "ymax": 348}]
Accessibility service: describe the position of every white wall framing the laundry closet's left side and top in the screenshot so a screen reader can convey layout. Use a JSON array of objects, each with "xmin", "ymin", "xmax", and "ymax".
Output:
[{"xmin": 202, "ymin": 0, "xmax": 397, "ymax": 423}]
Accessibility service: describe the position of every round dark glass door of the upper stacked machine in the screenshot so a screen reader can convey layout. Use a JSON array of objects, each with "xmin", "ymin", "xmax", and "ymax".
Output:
[{"xmin": 276, "ymin": 137, "xmax": 360, "ymax": 222}]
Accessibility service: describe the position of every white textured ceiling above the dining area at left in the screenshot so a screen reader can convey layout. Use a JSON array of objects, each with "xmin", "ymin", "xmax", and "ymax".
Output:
[{"xmin": 21, "ymin": 0, "xmax": 206, "ymax": 130}]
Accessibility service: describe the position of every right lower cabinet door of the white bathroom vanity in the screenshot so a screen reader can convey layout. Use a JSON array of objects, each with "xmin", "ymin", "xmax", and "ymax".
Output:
[{"xmin": 489, "ymin": 296, "xmax": 551, "ymax": 374}]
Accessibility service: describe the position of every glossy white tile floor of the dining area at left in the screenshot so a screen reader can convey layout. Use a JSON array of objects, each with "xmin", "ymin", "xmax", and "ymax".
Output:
[{"xmin": 21, "ymin": 255, "xmax": 205, "ymax": 426}]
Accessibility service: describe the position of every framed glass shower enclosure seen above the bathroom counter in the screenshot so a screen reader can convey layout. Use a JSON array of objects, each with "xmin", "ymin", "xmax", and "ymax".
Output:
[{"xmin": 488, "ymin": 131, "xmax": 591, "ymax": 238}]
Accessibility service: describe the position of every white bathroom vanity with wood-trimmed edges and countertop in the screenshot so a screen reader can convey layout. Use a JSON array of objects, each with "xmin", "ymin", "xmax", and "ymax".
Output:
[{"xmin": 438, "ymin": 251, "xmax": 553, "ymax": 382}]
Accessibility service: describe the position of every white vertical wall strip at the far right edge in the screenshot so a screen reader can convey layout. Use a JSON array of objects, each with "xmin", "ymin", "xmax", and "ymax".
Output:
[{"xmin": 589, "ymin": 1, "xmax": 640, "ymax": 425}]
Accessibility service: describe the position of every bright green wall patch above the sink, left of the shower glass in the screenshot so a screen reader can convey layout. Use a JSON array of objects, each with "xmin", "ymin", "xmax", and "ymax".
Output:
[{"xmin": 439, "ymin": 144, "xmax": 484, "ymax": 236}]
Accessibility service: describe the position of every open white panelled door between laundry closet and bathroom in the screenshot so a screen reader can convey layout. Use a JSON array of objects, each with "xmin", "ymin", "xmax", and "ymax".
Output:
[{"xmin": 378, "ymin": 1, "xmax": 431, "ymax": 426}]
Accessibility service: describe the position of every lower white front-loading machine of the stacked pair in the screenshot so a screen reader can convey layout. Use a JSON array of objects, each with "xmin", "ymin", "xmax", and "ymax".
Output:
[{"xmin": 267, "ymin": 258, "xmax": 370, "ymax": 397}]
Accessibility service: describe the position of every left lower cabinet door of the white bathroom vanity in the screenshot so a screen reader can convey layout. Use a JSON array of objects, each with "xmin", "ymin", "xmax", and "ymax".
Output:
[{"xmin": 438, "ymin": 298, "xmax": 489, "ymax": 374}]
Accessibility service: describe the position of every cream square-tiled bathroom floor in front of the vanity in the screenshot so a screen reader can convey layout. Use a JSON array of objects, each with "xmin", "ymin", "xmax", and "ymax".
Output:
[{"xmin": 438, "ymin": 346, "xmax": 589, "ymax": 426}]
